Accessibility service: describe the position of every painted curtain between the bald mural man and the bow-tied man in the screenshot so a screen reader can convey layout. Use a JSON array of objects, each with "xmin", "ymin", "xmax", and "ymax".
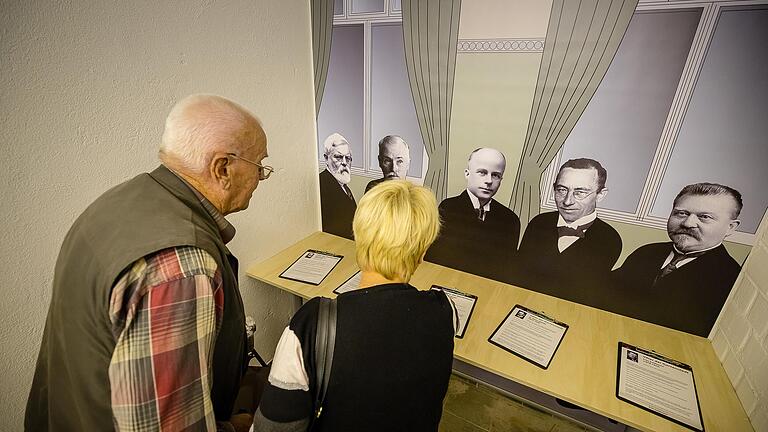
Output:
[{"xmin": 509, "ymin": 0, "xmax": 637, "ymax": 228}]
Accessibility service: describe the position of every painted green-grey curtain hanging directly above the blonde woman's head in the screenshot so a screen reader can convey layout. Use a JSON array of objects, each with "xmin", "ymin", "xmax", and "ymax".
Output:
[{"xmin": 402, "ymin": 0, "xmax": 461, "ymax": 200}]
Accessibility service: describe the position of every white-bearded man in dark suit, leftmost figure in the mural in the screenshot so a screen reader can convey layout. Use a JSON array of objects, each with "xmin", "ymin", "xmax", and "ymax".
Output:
[{"xmin": 320, "ymin": 133, "xmax": 357, "ymax": 240}]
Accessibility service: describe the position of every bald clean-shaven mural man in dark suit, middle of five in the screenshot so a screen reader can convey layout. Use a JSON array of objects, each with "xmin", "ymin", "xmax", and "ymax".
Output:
[{"xmin": 426, "ymin": 148, "xmax": 520, "ymax": 279}]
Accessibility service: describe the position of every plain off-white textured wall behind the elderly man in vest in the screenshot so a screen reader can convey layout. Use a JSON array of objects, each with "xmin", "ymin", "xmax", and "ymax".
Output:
[{"xmin": 0, "ymin": 0, "xmax": 319, "ymax": 431}]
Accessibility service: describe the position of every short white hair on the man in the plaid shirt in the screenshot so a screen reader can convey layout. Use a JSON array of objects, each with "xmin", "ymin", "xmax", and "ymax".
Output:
[{"xmin": 159, "ymin": 94, "xmax": 261, "ymax": 174}]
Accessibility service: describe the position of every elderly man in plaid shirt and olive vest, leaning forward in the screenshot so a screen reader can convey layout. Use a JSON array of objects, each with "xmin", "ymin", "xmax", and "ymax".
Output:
[{"xmin": 25, "ymin": 95, "xmax": 272, "ymax": 431}]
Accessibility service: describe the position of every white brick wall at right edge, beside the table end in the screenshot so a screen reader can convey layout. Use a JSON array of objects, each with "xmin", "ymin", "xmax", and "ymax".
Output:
[{"xmin": 710, "ymin": 213, "xmax": 768, "ymax": 432}]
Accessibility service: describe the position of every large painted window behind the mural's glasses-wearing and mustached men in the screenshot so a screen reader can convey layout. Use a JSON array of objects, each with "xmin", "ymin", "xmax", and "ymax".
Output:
[{"xmin": 542, "ymin": 2, "xmax": 768, "ymax": 244}]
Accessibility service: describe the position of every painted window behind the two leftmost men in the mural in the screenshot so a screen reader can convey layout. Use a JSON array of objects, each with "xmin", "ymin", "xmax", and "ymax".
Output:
[{"xmin": 317, "ymin": 0, "xmax": 426, "ymax": 180}]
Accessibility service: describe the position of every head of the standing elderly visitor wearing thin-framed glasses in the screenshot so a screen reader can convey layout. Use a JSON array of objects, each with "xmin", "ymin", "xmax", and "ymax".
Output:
[{"xmin": 159, "ymin": 94, "xmax": 267, "ymax": 215}]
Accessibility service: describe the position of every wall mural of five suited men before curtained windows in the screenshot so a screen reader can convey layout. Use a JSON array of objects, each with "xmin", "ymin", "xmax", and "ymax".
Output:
[{"xmin": 313, "ymin": 0, "xmax": 768, "ymax": 336}]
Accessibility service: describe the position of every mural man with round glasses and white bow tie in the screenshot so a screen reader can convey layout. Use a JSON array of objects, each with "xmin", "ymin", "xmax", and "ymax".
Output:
[{"xmin": 508, "ymin": 158, "xmax": 621, "ymax": 305}]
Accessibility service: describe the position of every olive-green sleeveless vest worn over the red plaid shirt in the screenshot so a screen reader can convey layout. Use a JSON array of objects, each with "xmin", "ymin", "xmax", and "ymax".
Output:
[{"xmin": 24, "ymin": 165, "xmax": 246, "ymax": 431}]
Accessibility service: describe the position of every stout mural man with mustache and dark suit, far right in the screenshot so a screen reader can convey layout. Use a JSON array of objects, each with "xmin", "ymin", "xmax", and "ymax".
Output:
[{"xmin": 613, "ymin": 183, "xmax": 742, "ymax": 337}]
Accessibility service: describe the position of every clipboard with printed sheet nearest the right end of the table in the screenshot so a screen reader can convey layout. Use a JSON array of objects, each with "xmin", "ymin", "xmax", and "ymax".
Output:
[{"xmin": 616, "ymin": 342, "xmax": 704, "ymax": 432}]
